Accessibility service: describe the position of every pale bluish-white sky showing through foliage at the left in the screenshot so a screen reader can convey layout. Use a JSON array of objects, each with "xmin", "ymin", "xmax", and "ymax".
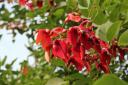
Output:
[{"xmin": 0, "ymin": 2, "xmax": 34, "ymax": 70}]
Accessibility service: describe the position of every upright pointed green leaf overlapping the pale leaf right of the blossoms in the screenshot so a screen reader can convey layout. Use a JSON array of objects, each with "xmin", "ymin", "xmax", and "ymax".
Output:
[{"xmin": 107, "ymin": 21, "xmax": 121, "ymax": 41}]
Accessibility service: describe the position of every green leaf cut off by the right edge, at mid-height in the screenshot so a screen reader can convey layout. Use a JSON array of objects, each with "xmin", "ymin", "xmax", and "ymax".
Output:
[{"xmin": 118, "ymin": 30, "xmax": 128, "ymax": 46}]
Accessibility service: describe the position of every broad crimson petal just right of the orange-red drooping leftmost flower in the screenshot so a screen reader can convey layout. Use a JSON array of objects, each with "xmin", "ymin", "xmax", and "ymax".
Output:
[{"xmin": 52, "ymin": 40, "xmax": 69, "ymax": 63}]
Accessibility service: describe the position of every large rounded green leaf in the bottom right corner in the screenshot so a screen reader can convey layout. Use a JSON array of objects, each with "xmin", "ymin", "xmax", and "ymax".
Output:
[{"xmin": 93, "ymin": 74, "xmax": 128, "ymax": 85}]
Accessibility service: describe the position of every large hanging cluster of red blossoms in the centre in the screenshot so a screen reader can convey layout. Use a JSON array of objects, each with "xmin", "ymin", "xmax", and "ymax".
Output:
[{"xmin": 36, "ymin": 13, "xmax": 125, "ymax": 73}]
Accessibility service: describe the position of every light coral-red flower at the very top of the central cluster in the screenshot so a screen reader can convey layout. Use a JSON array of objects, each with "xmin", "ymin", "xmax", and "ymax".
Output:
[{"xmin": 64, "ymin": 13, "xmax": 82, "ymax": 23}]
